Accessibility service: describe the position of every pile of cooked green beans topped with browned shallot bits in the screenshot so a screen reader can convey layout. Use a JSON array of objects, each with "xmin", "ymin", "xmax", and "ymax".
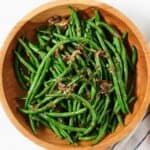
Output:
[{"xmin": 14, "ymin": 7, "xmax": 137, "ymax": 144}]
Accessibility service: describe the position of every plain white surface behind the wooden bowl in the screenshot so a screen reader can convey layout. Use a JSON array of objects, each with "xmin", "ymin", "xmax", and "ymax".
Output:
[{"xmin": 0, "ymin": 0, "xmax": 150, "ymax": 150}]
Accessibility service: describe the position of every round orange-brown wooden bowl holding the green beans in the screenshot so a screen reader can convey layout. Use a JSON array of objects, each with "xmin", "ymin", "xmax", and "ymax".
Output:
[{"xmin": 0, "ymin": 0, "xmax": 150, "ymax": 150}]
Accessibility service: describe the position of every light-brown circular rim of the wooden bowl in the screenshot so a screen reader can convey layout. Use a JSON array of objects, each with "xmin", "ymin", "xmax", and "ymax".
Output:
[{"xmin": 0, "ymin": 0, "xmax": 150, "ymax": 150}]
